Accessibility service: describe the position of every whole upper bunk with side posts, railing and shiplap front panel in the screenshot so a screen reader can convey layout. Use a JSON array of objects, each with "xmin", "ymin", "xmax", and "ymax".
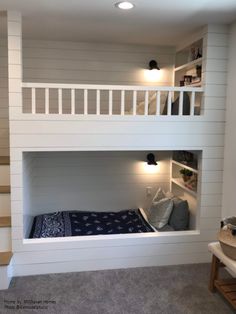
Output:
[{"xmin": 5, "ymin": 14, "xmax": 227, "ymax": 150}]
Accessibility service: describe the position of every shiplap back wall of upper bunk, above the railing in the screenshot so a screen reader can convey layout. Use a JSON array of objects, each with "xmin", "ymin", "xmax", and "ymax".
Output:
[{"xmin": 23, "ymin": 40, "xmax": 175, "ymax": 86}]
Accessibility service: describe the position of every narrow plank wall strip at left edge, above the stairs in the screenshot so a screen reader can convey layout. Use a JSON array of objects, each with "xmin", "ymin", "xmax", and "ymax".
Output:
[{"xmin": 0, "ymin": 12, "xmax": 10, "ymax": 156}]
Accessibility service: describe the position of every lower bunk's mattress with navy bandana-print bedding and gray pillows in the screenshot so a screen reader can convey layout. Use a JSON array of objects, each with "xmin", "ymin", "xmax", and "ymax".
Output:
[{"xmin": 29, "ymin": 189, "xmax": 189, "ymax": 238}]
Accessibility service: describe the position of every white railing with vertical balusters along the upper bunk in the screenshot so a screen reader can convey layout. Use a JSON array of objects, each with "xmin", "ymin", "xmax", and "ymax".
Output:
[{"xmin": 22, "ymin": 83, "xmax": 204, "ymax": 116}]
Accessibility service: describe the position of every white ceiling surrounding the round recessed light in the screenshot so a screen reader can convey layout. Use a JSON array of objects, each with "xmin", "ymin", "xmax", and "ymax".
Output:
[{"xmin": 0, "ymin": 0, "xmax": 236, "ymax": 45}]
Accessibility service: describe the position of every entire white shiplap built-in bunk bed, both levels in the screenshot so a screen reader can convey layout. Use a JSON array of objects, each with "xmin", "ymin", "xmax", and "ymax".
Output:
[{"xmin": 4, "ymin": 13, "xmax": 227, "ymax": 284}]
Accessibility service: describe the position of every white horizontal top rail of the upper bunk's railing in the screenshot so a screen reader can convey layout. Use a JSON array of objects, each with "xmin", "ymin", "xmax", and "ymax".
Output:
[{"xmin": 22, "ymin": 82, "xmax": 204, "ymax": 92}]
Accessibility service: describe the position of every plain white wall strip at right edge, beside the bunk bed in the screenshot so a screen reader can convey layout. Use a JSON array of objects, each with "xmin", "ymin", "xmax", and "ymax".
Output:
[{"xmin": 222, "ymin": 22, "xmax": 236, "ymax": 217}]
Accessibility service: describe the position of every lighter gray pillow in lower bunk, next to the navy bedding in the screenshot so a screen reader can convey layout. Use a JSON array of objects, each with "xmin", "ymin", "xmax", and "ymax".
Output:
[{"xmin": 146, "ymin": 198, "xmax": 173, "ymax": 229}]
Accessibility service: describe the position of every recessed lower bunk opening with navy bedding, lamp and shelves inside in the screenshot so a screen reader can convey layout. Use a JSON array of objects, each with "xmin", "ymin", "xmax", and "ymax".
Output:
[{"xmin": 23, "ymin": 150, "xmax": 201, "ymax": 240}]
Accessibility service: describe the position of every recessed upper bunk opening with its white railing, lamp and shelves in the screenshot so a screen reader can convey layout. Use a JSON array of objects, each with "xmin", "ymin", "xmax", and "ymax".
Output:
[{"xmin": 19, "ymin": 39, "xmax": 204, "ymax": 121}]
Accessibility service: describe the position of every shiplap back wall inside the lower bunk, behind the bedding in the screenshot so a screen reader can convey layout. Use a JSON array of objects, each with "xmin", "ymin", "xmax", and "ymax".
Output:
[{"xmin": 24, "ymin": 151, "xmax": 171, "ymax": 215}]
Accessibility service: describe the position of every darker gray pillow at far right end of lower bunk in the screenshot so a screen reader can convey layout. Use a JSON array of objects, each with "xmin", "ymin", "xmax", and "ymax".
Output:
[{"xmin": 168, "ymin": 197, "xmax": 189, "ymax": 231}]
